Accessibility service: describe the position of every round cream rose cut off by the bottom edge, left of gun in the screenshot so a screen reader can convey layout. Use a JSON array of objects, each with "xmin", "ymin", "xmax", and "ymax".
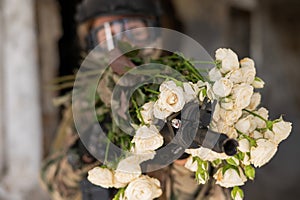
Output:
[{"xmin": 125, "ymin": 176, "xmax": 162, "ymax": 200}]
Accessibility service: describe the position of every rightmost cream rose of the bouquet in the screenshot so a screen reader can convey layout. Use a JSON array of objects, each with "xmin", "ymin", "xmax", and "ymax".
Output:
[{"xmin": 272, "ymin": 120, "xmax": 292, "ymax": 144}]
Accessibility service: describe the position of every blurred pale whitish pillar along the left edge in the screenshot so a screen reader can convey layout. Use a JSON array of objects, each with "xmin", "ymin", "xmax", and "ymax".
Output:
[{"xmin": 0, "ymin": 0, "xmax": 42, "ymax": 200}]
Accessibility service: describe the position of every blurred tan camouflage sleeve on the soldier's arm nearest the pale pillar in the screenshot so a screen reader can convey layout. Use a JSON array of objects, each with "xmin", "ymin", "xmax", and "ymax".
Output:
[{"xmin": 40, "ymin": 106, "xmax": 99, "ymax": 200}]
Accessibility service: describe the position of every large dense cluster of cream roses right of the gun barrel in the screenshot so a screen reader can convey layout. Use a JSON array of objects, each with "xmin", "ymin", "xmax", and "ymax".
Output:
[{"xmin": 186, "ymin": 49, "xmax": 292, "ymax": 199}]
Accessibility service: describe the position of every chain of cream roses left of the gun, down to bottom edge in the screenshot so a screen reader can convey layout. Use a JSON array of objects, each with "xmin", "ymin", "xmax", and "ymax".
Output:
[{"xmin": 88, "ymin": 119, "xmax": 164, "ymax": 200}]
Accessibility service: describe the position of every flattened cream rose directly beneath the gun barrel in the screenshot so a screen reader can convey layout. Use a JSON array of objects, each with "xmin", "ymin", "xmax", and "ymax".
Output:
[{"xmin": 185, "ymin": 147, "xmax": 230, "ymax": 161}]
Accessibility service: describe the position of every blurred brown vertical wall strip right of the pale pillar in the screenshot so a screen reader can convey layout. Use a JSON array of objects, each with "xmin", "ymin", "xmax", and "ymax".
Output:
[{"xmin": 36, "ymin": 0, "xmax": 62, "ymax": 156}]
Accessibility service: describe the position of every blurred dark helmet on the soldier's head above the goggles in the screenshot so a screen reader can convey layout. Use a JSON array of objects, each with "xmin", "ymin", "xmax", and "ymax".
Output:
[{"xmin": 76, "ymin": 0, "xmax": 162, "ymax": 23}]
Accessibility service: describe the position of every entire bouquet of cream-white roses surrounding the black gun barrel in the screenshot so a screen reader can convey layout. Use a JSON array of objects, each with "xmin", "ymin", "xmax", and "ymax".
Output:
[{"xmin": 88, "ymin": 49, "xmax": 292, "ymax": 200}]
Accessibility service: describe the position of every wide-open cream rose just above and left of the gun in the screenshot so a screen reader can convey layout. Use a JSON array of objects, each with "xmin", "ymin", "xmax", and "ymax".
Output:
[{"xmin": 154, "ymin": 81, "xmax": 185, "ymax": 119}]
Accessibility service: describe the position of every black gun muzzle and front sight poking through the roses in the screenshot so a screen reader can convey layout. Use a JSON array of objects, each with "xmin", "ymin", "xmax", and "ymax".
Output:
[{"xmin": 160, "ymin": 98, "xmax": 238, "ymax": 156}]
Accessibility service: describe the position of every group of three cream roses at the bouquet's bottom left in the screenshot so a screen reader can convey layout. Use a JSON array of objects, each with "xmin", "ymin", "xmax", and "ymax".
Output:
[{"xmin": 88, "ymin": 156, "xmax": 162, "ymax": 200}]
